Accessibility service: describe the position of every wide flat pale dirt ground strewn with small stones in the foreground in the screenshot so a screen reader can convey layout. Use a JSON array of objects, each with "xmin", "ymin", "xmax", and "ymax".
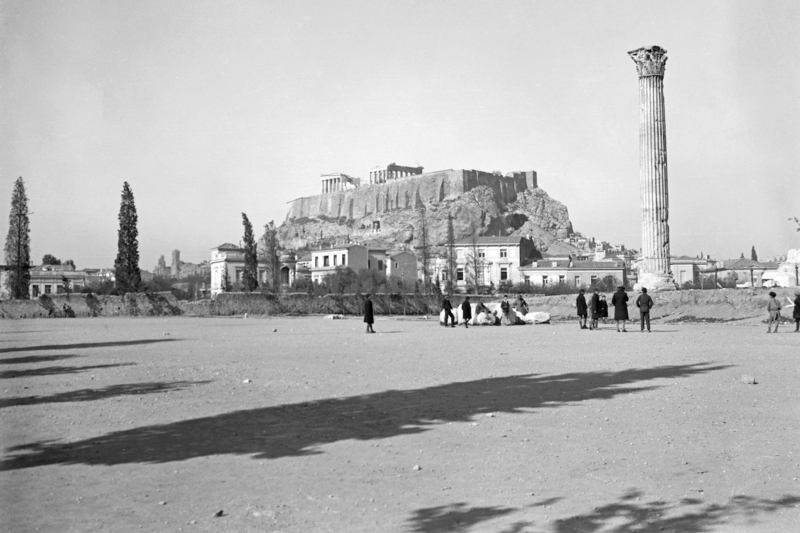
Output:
[{"xmin": 0, "ymin": 317, "xmax": 800, "ymax": 533}]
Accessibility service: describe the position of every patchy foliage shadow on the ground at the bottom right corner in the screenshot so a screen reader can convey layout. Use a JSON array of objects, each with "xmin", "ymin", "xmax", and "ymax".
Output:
[{"xmin": 408, "ymin": 490, "xmax": 800, "ymax": 533}]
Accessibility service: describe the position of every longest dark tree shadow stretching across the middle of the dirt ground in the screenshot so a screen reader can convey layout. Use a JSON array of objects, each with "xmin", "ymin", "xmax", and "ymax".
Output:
[{"xmin": 0, "ymin": 363, "xmax": 728, "ymax": 470}]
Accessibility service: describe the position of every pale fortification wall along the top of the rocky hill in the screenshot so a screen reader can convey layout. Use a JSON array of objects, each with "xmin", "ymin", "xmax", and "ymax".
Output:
[{"xmin": 286, "ymin": 170, "xmax": 536, "ymax": 222}]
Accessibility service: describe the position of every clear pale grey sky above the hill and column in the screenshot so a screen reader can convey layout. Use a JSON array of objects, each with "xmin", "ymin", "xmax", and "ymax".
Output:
[{"xmin": 0, "ymin": 0, "xmax": 800, "ymax": 270}]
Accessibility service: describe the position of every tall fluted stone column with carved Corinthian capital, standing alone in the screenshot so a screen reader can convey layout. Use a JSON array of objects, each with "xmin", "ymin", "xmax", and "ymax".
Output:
[{"xmin": 628, "ymin": 46, "xmax": 676, "ymax": 291}]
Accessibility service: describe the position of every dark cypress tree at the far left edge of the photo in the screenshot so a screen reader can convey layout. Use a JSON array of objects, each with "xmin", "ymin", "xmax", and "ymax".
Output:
[{"xmin": 5, "ymin": 176, "xmax": 31, "ymax": 299}]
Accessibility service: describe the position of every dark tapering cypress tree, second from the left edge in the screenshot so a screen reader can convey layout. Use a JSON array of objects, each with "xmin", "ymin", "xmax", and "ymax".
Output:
[{"xmin": 114, "ymin": 181, "xmax": 142, "ymax": 295}]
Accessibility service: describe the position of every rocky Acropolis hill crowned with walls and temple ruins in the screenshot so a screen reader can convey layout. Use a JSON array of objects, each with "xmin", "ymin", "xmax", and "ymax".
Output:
[{"xmin": 279, "ymin": 164, "xmax": 572, "ymax": 251}]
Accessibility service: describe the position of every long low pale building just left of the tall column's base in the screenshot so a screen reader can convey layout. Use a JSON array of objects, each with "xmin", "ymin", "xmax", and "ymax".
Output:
[{"xmin": 520, "ymin": 256, "xmax": 628, "ymax": 287}]
